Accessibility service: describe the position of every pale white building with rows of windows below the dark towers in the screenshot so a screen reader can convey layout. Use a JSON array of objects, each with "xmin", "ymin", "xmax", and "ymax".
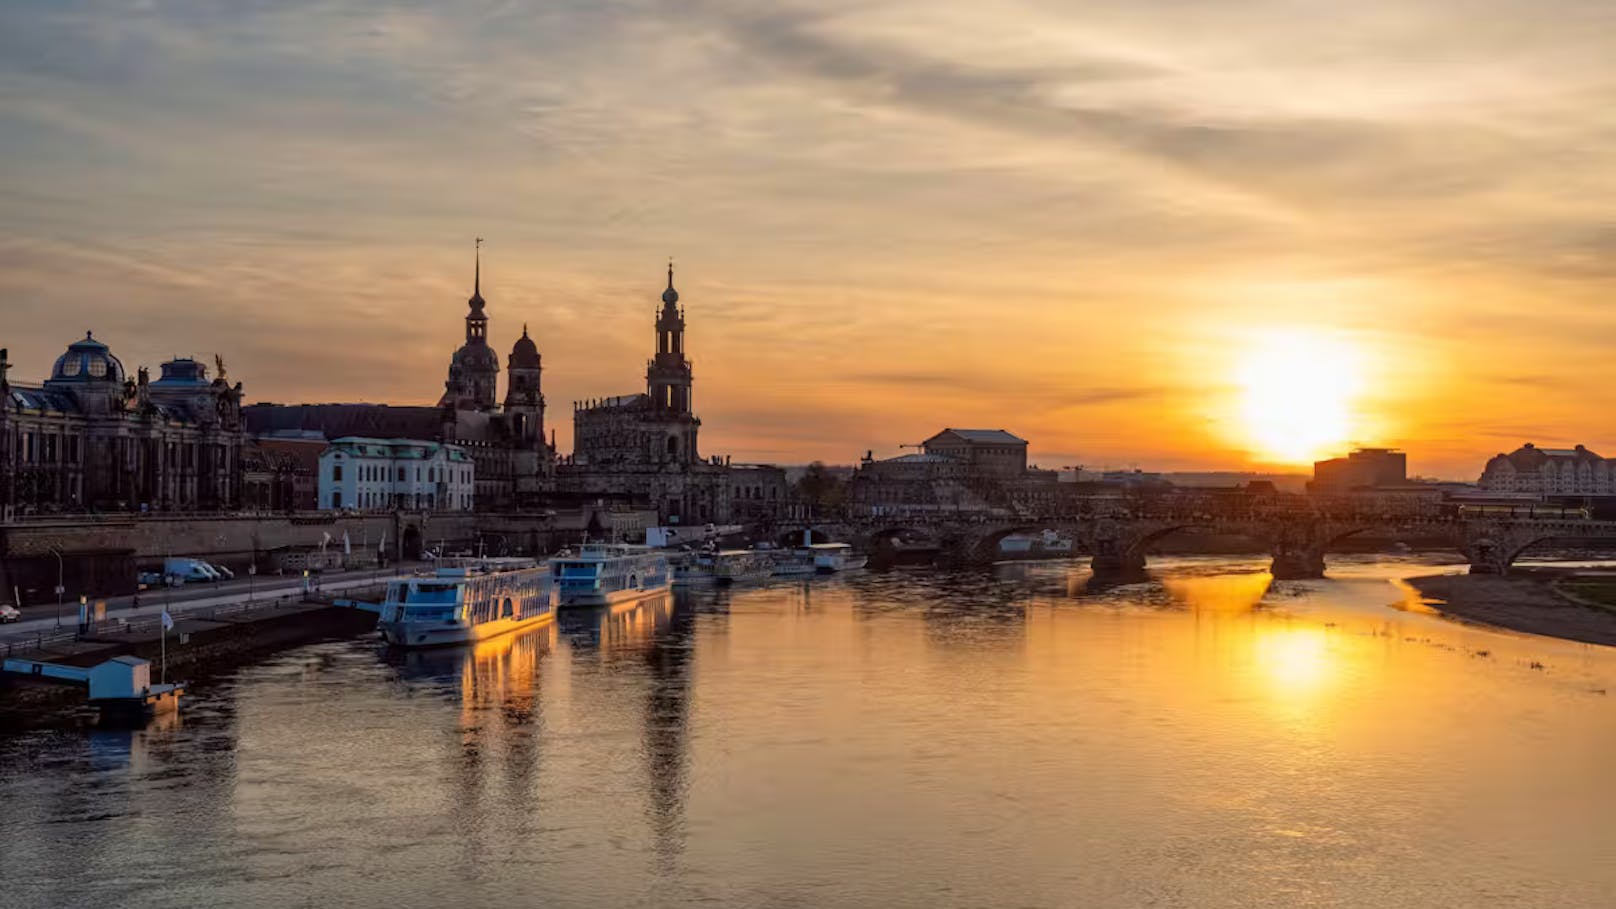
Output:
[{"xmin": 318, "ymin": 437, "xmax": 477, "ymax": 511}]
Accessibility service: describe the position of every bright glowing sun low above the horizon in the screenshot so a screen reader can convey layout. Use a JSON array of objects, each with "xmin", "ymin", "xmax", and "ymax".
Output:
[{"xmin": 1236, "ymin": 330, "xmax": 1364, "ymax": 464}]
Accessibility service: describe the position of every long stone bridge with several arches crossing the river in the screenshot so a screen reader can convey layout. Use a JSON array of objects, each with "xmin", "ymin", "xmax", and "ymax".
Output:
[{"xmin": 816, "ymin": 514, "xmax": 1616, "ymax": 579}]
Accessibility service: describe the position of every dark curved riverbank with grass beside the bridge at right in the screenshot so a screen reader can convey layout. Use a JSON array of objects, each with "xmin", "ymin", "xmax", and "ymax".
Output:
[{"xmin": 1408, "ymin": 568, "xmax": 1616, "ymax": 647}]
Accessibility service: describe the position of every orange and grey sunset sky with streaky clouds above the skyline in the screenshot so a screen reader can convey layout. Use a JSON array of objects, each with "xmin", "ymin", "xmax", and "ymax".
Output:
[{"xmin": 0, "ymin": 0, "xmax": 1616, "ymax": 479}]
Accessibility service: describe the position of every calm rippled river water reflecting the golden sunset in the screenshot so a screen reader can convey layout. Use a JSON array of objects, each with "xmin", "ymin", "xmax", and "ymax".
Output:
[{"xmin": 0, "ymin": 558, "xmax": 1616, "ymax": 909}]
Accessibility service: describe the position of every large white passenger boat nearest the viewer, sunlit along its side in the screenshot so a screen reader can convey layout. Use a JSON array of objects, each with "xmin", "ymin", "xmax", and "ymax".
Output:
[{"xmin": 377, "ymin": 558, "xmax": 556, "ymax": 647}]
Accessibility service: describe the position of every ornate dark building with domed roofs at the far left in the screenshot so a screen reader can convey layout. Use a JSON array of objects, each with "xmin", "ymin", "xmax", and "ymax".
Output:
[{"xmin": 0, "ymin": 332, "xmax": 242, "ymax": 514}]
